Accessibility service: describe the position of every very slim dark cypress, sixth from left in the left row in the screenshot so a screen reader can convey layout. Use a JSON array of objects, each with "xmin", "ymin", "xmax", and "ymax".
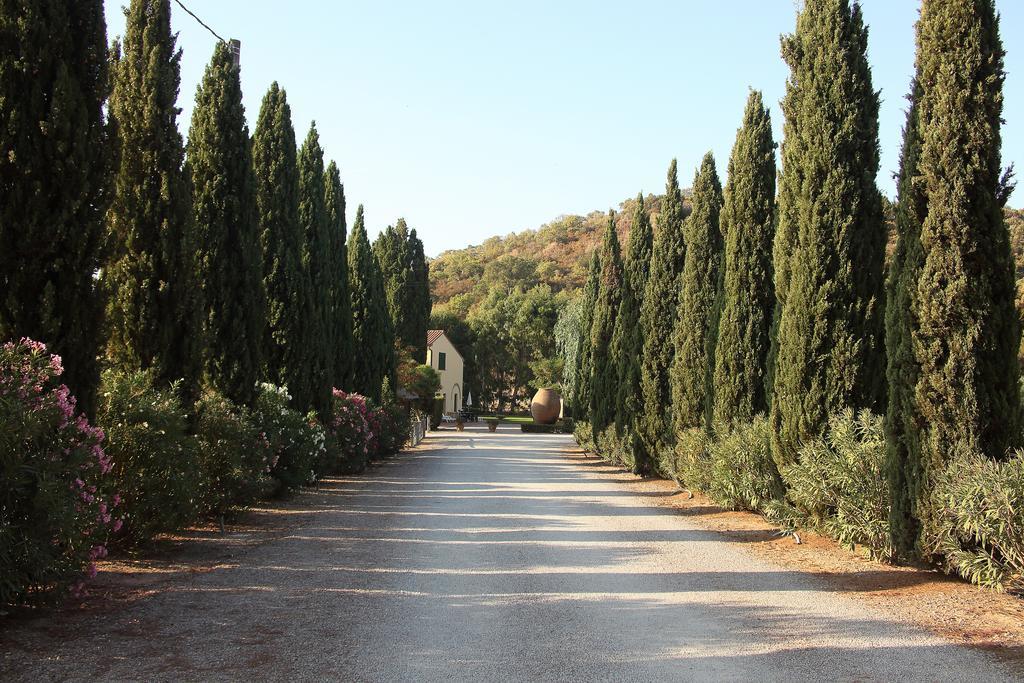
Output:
[{"xmin": 324, "ymin": 162, "xmax": 353, "ymax": 388}]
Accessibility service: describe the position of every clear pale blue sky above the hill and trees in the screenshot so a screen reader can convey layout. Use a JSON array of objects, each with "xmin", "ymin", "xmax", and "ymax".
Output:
[{"xmin": 105, "ymin": 0, "xmax": 1024, "ymax": 256}]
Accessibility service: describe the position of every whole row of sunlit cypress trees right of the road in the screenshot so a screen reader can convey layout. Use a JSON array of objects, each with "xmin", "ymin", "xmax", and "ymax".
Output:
[{"xmin": 570, "ymin": 0, "xmax": 1021, "ymax": 557}]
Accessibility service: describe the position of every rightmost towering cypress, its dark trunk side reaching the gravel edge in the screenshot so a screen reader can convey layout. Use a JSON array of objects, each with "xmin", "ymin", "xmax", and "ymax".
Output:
[{"xmin": 887, "ymin": 0, "xmax": 1020, "ymax": 557}]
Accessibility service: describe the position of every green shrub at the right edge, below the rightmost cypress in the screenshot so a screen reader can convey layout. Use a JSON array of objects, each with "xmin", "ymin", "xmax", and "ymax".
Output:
[{"xmin": 926, "ymin": 451, "xmax": 1024, "ymax": 593}]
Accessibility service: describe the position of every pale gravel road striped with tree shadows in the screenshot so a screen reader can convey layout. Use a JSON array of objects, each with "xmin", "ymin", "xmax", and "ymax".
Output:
[{"xmin": 0, "ymin": 426, "xmax": 1013, "ymax": 681}]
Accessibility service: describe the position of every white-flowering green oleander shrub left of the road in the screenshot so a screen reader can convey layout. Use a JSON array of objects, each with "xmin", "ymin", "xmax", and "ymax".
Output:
[{"xmin": 252, "ymin": 384, "xmax": 327, "ymax": 495}]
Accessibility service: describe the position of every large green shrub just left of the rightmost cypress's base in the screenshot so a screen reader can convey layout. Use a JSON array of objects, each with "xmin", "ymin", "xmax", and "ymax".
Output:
[{"xmin": 768, "ymin": 410, "xmax": 894, "ymax": 559}]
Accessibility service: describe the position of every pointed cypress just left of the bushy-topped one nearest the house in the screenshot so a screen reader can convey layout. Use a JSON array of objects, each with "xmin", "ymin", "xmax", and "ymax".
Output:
[{"xmin": 348, "ymin": 204, "xmax": 395, "ymax": 400}]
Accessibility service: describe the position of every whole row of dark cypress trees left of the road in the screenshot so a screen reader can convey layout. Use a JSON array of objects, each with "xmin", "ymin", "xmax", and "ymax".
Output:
[{"xmin": 0, "ymin": 0, "xmax": 429, "ymax": 415}]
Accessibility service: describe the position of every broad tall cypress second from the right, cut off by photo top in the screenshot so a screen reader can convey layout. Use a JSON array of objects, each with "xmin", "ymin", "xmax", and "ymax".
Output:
[{"xmin": 771, "ymin": 0, "xmax": 886, "ymax": 464}]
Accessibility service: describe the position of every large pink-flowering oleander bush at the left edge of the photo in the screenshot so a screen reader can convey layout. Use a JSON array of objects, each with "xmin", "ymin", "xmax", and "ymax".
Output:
[{"xmin": 0, "ymin": 339, "xmax": 121, "ymax": 605}]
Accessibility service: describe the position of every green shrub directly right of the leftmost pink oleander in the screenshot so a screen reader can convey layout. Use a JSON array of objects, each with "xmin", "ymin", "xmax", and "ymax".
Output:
[{"xmin": 96, "ymin": 370, "xmax": 206, "ymax": 545}]
